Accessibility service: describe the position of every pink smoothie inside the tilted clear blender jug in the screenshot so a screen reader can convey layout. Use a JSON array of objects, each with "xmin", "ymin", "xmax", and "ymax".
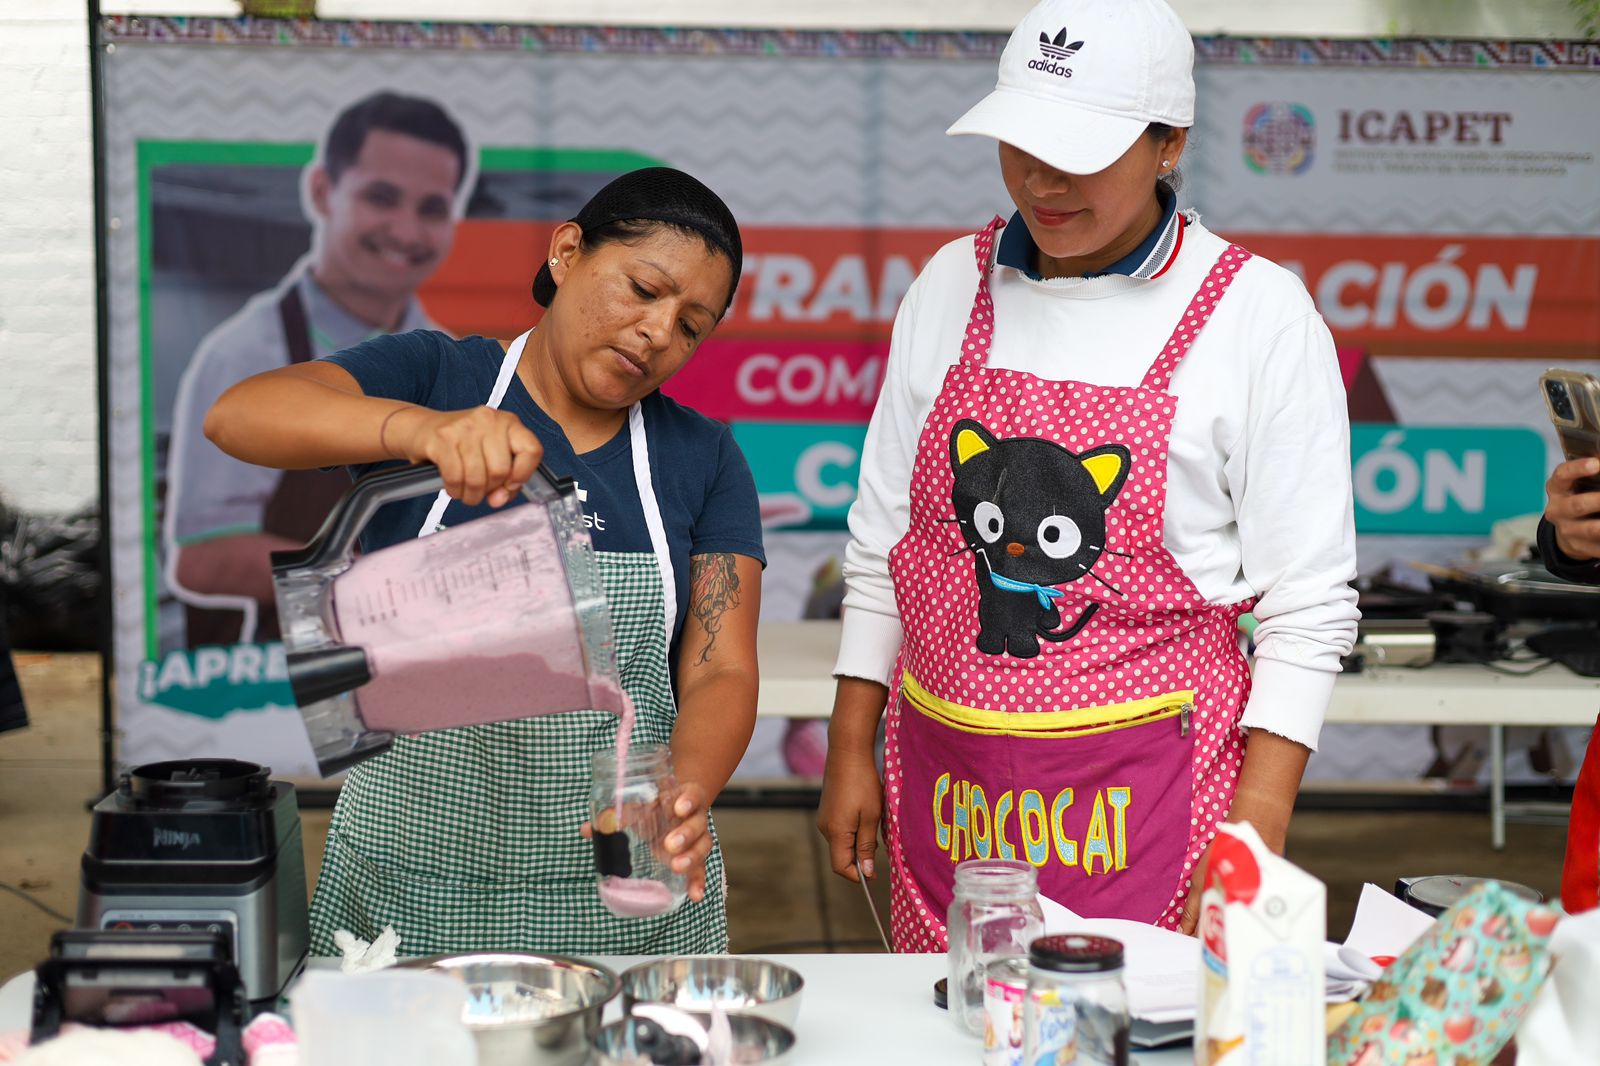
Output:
[{"xmin": 333, "ymin": 506, "xmax": 622, "ymax": 733}]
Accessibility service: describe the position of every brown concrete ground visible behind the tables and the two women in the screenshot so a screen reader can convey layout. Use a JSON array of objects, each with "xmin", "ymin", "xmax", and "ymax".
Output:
[{"xmin": 0, "ymin": 653, "xmax": 1565, "ymax": 983}]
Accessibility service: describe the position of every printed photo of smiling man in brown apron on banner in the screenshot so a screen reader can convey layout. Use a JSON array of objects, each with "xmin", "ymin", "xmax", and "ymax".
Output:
[{"xmin": 163, "ymin": 91, "xmax": 475, "ymax": 648}]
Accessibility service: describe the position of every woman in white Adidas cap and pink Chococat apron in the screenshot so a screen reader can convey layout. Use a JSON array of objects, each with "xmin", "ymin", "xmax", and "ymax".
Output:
[{"xmin": 818, "ymin": 0, "xmax": 1357, "ymax": 951}]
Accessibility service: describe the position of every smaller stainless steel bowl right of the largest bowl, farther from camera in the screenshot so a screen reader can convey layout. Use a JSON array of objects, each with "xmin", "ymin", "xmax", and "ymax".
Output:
[{"xmin": 622, "ymin": 956, "xmax": 805, "ymax": 1029}]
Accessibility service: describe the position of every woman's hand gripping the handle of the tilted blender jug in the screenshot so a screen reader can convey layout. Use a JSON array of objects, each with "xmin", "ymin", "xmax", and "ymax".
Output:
[{"xmin": 382, "ymin": 407, "xmax": 544, "ymax": 507}]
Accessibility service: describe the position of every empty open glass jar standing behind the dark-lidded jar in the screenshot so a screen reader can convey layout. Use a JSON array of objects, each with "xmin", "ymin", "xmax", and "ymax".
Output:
[{"xmin": 946, "ymin": 860, "xmax": 1045, "ymax": 1036}]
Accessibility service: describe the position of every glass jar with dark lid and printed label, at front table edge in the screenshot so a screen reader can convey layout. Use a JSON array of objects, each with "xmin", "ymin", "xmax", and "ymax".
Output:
[{"xmin": 1022, "ymin": 933, "xmax": 1133, "ymax": 1066}]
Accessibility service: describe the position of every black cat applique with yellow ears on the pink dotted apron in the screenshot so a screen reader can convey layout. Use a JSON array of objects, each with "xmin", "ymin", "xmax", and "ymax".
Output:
[{"xmin": 950, "ymin": 418, "xmax": 1133, "ymax": 659}]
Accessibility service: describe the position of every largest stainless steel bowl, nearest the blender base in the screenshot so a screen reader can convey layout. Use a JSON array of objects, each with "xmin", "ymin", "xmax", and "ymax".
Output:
[{"xmin": 400, "ymin": 952, "xmax": 619, "ymax": 1066}]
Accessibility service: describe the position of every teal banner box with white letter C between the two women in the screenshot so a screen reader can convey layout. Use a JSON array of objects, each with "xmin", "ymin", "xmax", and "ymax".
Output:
[{"xmin": 733, "ymin": 423, "xmax": 867, "ymax": 530}]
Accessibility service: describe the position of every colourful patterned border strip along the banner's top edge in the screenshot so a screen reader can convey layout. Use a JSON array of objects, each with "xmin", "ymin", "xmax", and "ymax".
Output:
[{"xmin": 101, "ymin": 14, "xmax": 1600, "ymax": 70}]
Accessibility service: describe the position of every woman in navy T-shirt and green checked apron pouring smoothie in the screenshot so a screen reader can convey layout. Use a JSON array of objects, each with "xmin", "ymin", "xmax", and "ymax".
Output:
[{"xmin": 205, "ymin": 168, "xmax": 763, "ymax": 954}]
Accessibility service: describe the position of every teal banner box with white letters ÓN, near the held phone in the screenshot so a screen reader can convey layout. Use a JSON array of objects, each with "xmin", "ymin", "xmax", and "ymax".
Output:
[{"xmin": 1350, "ymin": 423, "xmax": 1546, "ymax": 536}]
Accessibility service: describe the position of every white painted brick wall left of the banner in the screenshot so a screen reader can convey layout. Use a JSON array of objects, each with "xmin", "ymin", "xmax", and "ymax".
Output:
[{"xmin": 0, "ymin": 0, "xmax": 98, "ymax": 511}]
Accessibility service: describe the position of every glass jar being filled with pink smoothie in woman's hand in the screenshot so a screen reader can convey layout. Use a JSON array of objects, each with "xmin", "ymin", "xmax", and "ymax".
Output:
[{"xmin": 589, "ymin": 744, "xmax": 688, "ymax": 917}]
